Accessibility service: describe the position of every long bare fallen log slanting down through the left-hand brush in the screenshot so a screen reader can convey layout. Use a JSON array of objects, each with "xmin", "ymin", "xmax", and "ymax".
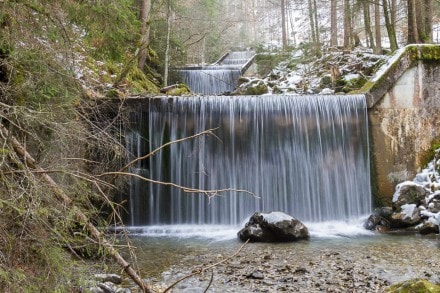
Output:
[{"xmin": 0, "ymin": 123, "xmax": 153, "ymax": 293}]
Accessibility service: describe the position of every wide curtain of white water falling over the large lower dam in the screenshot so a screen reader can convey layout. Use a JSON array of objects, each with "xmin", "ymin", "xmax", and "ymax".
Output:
[{"xmin": 126, "ymin": 95, "xmax": 371, "ymax": 225}]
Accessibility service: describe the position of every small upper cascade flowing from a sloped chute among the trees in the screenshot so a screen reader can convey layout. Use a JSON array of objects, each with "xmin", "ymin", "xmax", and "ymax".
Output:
[{"xmin": 178, "ymin": 51, "xmax": 255, "ymax": 95}]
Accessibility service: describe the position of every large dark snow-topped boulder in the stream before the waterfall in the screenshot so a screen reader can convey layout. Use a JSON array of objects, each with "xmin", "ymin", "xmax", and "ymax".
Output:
[{"xmin": 238, "ymin": 212, "xmax": 309, "ymax": 242}]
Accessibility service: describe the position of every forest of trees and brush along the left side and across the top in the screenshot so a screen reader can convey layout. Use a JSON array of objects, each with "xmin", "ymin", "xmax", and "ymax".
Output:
[{"xmin": 0, "ymin": 0, "xmax": 440, "ymax": 292}]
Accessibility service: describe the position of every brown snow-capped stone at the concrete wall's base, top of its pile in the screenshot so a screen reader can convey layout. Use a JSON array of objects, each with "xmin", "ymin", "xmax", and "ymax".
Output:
[{"xmin": 393, "ymin": 181, "xmax": 430, "ymax": 211}]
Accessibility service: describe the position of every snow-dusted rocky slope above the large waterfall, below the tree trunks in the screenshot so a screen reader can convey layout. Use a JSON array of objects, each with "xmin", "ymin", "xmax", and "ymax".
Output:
[{"xmin": 237, "ymin": 47, "xmax": 391, "ymax": 94}]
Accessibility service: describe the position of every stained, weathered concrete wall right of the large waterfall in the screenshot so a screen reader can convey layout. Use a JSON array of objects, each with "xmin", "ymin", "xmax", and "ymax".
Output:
[{"xmin": 367, "ymin": 46, "xmax": 440, "ymax": 205}]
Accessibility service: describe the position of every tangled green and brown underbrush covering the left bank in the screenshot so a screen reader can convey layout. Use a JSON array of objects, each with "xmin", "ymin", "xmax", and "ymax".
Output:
[{"xmin": 0, "ymin": 0, "xmax": 144, "ymax": 292}]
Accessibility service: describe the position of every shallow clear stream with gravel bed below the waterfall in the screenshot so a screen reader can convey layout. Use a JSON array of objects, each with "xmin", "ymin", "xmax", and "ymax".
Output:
[{"xmin": 127, "ymin": 234, "xmax": 440, "ymax": 292}]
